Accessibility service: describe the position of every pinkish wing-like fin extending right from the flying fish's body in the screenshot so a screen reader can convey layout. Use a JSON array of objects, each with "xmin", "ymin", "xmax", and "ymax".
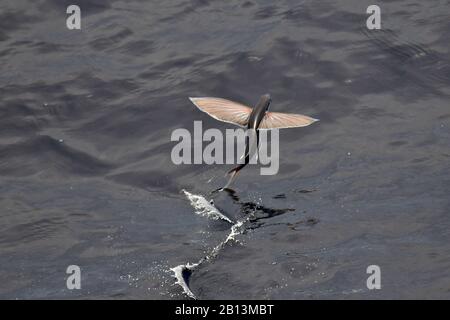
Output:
[{"xmin": 258, "ymin": 112, "xmax": 319, "ymax": 129}]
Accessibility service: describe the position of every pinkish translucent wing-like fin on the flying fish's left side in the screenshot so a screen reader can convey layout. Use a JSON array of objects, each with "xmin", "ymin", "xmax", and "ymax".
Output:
[{"xmin": 189, "ymin": 98, "xmax": 252, "ymax": 127}]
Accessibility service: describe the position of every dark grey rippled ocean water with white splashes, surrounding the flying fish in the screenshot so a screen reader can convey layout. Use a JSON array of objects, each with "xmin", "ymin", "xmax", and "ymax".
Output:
[{"xmin": 0, "ymin": 0, "xmax": 450, "ymax": 299}]
